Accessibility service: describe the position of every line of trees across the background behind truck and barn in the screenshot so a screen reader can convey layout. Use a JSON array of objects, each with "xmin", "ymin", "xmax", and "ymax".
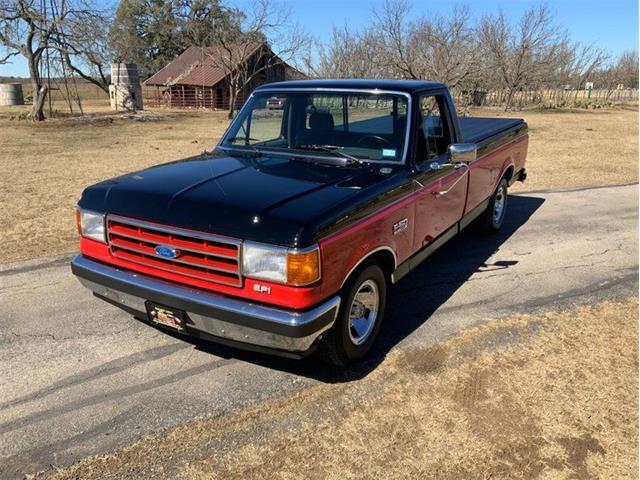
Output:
[{"xmin": 0, "ymin": 0, "xmax": 638, "ymax": 120}]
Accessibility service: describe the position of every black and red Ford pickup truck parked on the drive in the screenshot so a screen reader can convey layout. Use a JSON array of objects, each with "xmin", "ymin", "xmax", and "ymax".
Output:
[{"xmin": 71, "ymin": 80, "xmax": 528, "ymax": 364}]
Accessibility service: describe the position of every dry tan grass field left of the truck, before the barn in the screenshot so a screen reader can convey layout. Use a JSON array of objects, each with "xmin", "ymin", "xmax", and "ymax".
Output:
[{"xmin": 0, "ymin": 102, "xmax": 227, "ymax": 262}]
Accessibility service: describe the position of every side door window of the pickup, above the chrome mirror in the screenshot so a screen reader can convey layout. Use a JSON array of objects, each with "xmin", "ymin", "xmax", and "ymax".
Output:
[{"xmin": 416, "ymin": 95, "xmax": 451, "ymax": 162}]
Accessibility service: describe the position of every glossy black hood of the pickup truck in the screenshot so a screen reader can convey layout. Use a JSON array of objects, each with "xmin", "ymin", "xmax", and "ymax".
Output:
[{"xmin": 78, "ymin": 153, "xmax": 400, "ymax": 246}]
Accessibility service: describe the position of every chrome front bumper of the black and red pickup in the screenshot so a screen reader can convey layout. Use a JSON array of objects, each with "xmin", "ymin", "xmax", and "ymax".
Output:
[{"xmin": 71, "ymin": 255, "xmax": 340, "ymax": 354}]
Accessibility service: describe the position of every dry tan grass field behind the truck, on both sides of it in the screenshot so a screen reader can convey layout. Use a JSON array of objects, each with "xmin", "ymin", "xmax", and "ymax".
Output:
[{"xmin": 0, "ymin": 102, "xmax": 638, "ymax": 264}]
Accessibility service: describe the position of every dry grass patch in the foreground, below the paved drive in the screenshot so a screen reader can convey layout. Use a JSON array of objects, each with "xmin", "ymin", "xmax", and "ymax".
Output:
[{"xmin": 36, "ymin": 299, "xmax": 638, "ymax": 479}]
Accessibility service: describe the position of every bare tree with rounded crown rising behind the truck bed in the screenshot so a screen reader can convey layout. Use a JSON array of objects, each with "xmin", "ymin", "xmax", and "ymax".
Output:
[{"xmin": 479, "ymin": 5, "xmax": 563, "ymax": 108}]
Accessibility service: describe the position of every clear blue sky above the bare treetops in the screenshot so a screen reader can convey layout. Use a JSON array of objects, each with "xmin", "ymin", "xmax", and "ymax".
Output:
[{"xmin": 0, "ymin": 0, "xmax": 638, "ymax": 76}]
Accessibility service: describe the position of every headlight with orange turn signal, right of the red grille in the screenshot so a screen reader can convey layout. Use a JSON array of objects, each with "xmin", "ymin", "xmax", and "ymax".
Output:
[{"xmin": 242, "ymin": 242, "xmax": 320, "ymax": 286}]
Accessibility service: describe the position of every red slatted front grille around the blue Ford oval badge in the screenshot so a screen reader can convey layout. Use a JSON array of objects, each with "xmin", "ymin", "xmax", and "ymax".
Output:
[{"xmin": 107, "ymin": 215, "xmax": 242, "ymax": 287}]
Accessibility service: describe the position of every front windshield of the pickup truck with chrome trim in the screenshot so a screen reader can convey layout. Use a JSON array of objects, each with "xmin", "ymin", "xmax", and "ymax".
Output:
[{"xmin": 220, "ymin": 91, "xmax": 408, "ymax": 162}]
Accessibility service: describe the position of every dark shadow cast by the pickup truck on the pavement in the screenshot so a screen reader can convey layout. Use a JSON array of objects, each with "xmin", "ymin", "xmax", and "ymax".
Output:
[{"xmin": 159, "ymin": 195, "xmax": 545, "ymax": 383}]
